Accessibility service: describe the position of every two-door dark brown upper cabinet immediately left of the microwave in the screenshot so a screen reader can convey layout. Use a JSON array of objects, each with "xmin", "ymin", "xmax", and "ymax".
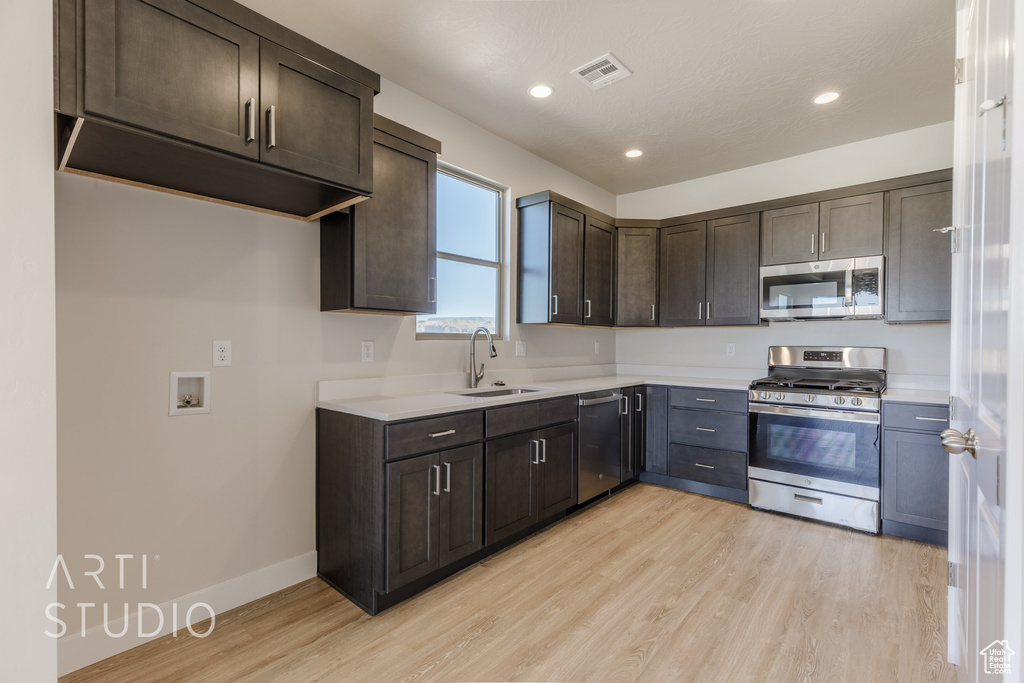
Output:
[{"xmin": 660, "ymin": 213, "xmax": 759, "ymax": 327}]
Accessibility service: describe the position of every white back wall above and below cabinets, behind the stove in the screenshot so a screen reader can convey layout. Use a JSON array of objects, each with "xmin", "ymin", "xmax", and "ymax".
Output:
[{"xmin": 615, "ymin": 122, "xmax": 953, "ymax": 378}]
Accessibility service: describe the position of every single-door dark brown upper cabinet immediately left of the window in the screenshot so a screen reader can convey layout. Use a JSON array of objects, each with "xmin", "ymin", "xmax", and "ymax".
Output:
[{"xmin": 321, "ymin": 116, "xmax": 440, "ymax": 313}]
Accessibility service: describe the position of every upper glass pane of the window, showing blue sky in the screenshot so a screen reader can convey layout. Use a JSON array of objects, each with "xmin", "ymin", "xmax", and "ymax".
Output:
[{"xmin": 437, "ymin": 173, "xmax": 500, "ymax": 261}]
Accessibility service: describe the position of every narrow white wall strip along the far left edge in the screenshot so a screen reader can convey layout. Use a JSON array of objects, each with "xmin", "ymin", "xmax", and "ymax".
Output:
[{"xmin": 0, "ymin": 2, "xmax": 56, "ymax": 681}]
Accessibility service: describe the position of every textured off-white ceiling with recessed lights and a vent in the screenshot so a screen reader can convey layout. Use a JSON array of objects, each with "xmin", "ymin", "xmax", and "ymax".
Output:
[{"xmin": 237, "ymin": 0, "xmax": 954, "ymax": 195}]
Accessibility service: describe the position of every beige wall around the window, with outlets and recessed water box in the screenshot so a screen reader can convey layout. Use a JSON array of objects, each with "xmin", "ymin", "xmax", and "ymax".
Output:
[{"xmin": 56, "ymin": 76, "xmax": 615, "ymax": 670}]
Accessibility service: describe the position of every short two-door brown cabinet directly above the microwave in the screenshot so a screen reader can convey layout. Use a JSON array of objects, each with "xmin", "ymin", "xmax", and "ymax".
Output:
[{"xmin": 761, "ymin": 193, "xmax": 885, "ymax": 265}]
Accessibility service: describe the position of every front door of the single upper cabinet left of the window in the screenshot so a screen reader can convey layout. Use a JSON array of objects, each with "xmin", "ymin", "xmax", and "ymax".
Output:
[{"xmin": 350, "ymin": 130, "xmax": 437, "ymax": 313}]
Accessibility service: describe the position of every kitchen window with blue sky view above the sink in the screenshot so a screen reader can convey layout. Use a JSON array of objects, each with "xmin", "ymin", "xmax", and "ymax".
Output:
[{"xmin": 416, "ymin": 166, "xmax": 506, "ymax": 339}]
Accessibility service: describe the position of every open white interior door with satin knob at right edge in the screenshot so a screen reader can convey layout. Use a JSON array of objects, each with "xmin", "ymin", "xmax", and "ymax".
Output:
[{"xmin": 944, "ymin": 0, "xmax": 1022, "ymax": 682}]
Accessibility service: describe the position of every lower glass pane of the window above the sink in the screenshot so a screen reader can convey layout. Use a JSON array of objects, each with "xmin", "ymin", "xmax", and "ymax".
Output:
[{"xmin": 416, "ymin": 258, "xmax": 498, "ymax": 335}]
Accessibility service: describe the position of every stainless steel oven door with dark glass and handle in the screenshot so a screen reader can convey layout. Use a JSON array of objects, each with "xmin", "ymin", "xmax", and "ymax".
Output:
[{"xmin": 749, "ymin": 403, "xmax": 881, "ymax": 501}]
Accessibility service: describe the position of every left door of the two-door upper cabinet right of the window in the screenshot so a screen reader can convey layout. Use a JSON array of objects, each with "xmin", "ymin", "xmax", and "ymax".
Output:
[{"xmin": 549, "ymin": 202, "xmax": 585, "ymax": 325}]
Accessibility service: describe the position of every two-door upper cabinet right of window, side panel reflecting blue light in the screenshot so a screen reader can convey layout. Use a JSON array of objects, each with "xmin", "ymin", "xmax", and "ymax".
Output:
[{"xmin": 516, "ymin": 193, "xmax": 615, "ymax": 326}]
